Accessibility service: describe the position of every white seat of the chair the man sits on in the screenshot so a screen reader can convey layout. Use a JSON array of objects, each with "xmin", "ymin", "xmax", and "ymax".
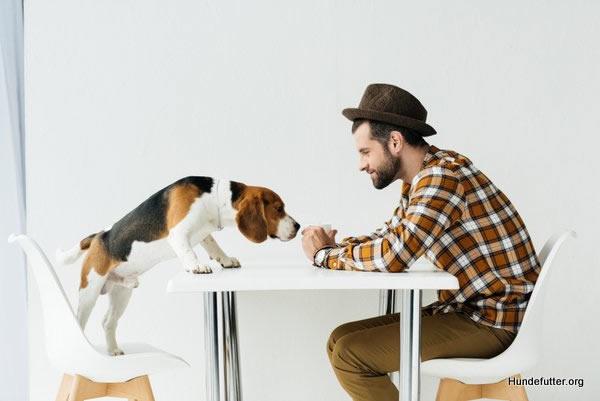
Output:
[{"xmin": 421, "ymin": 357, "xmax": 523, "ymax": 384}]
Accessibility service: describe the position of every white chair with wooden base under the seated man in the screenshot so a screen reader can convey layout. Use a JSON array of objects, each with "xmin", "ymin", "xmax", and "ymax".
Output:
[{"xmin": 421, "ymin": 231, "xmax": 576, "ymax": 401}]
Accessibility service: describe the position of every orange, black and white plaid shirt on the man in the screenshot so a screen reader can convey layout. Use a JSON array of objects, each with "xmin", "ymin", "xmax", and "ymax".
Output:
[{"xmin": 315, "ymin": 145, "xmax": 541, "ymax": 332}]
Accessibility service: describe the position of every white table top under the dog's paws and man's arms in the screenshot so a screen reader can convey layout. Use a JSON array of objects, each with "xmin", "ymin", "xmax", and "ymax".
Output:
[{"xmin": 167, "ymin": 258, "xmax": 458, "ymax": 293}]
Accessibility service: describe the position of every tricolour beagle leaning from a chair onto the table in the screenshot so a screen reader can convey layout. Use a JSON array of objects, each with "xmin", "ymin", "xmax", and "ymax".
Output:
[{"xmin": 56, "ymin": 177, "xmax": 300, "ymax": 355}]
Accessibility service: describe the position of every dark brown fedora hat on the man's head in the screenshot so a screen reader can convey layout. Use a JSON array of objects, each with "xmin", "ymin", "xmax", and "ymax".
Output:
[{"xmin": 342, "ymin": 84, "xmax": 436, "ymax": 136}]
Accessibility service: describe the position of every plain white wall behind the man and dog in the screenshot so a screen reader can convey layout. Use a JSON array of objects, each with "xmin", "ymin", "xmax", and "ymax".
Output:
[{"xmin": 25, "ymin": 0, "xmax": 600, "ymax": 401}]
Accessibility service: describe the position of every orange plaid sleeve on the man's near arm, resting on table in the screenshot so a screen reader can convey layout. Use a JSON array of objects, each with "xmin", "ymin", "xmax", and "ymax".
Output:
[{"xmin": 318, "ymin": 166, "xmax": 465, "ymax": 272}]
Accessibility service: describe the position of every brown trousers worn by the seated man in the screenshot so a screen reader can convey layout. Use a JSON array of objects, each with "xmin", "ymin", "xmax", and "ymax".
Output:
[{"xmin": 327, "ymin": 311, "xmax": 515, "ymax": 401}]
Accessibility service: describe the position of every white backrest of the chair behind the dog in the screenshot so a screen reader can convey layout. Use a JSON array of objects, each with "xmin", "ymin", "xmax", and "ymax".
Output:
[{"xmin": 8, "ymin": 234, "xmax": 94, "ymax": 363}]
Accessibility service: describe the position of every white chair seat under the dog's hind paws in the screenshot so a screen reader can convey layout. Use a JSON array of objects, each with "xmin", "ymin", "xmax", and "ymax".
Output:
[{"xmin": 56, "ymin": 343, "xmax": 190, "ymax": 383}]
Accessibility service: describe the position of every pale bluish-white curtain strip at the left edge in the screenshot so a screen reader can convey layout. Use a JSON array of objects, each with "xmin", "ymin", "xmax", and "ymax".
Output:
[{"xmin": 0, "ymin": 0, "xmax": 29, "ymax": 401}]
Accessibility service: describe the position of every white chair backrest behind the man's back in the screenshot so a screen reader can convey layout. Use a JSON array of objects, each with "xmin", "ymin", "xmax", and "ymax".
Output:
[{"xmin": 496, "ymin": 230, "xmax": 577, "ymax": 365}]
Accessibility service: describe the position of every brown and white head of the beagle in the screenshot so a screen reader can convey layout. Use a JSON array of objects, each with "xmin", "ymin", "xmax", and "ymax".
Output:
[{"xmin": 234, "ymin": 186, "xmax": 300, "ymax": 242}]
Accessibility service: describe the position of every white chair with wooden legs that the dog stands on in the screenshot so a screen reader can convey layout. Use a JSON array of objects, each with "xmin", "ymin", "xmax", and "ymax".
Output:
[{"xmin": 8, "ymin": 234, "xmax": 189, "ymax": 401}]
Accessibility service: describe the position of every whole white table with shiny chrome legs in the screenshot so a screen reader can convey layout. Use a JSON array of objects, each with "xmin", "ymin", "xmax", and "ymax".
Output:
[{"xmin": 167, "ymin": 258, "xmax": 458, "ymax": 401}]
